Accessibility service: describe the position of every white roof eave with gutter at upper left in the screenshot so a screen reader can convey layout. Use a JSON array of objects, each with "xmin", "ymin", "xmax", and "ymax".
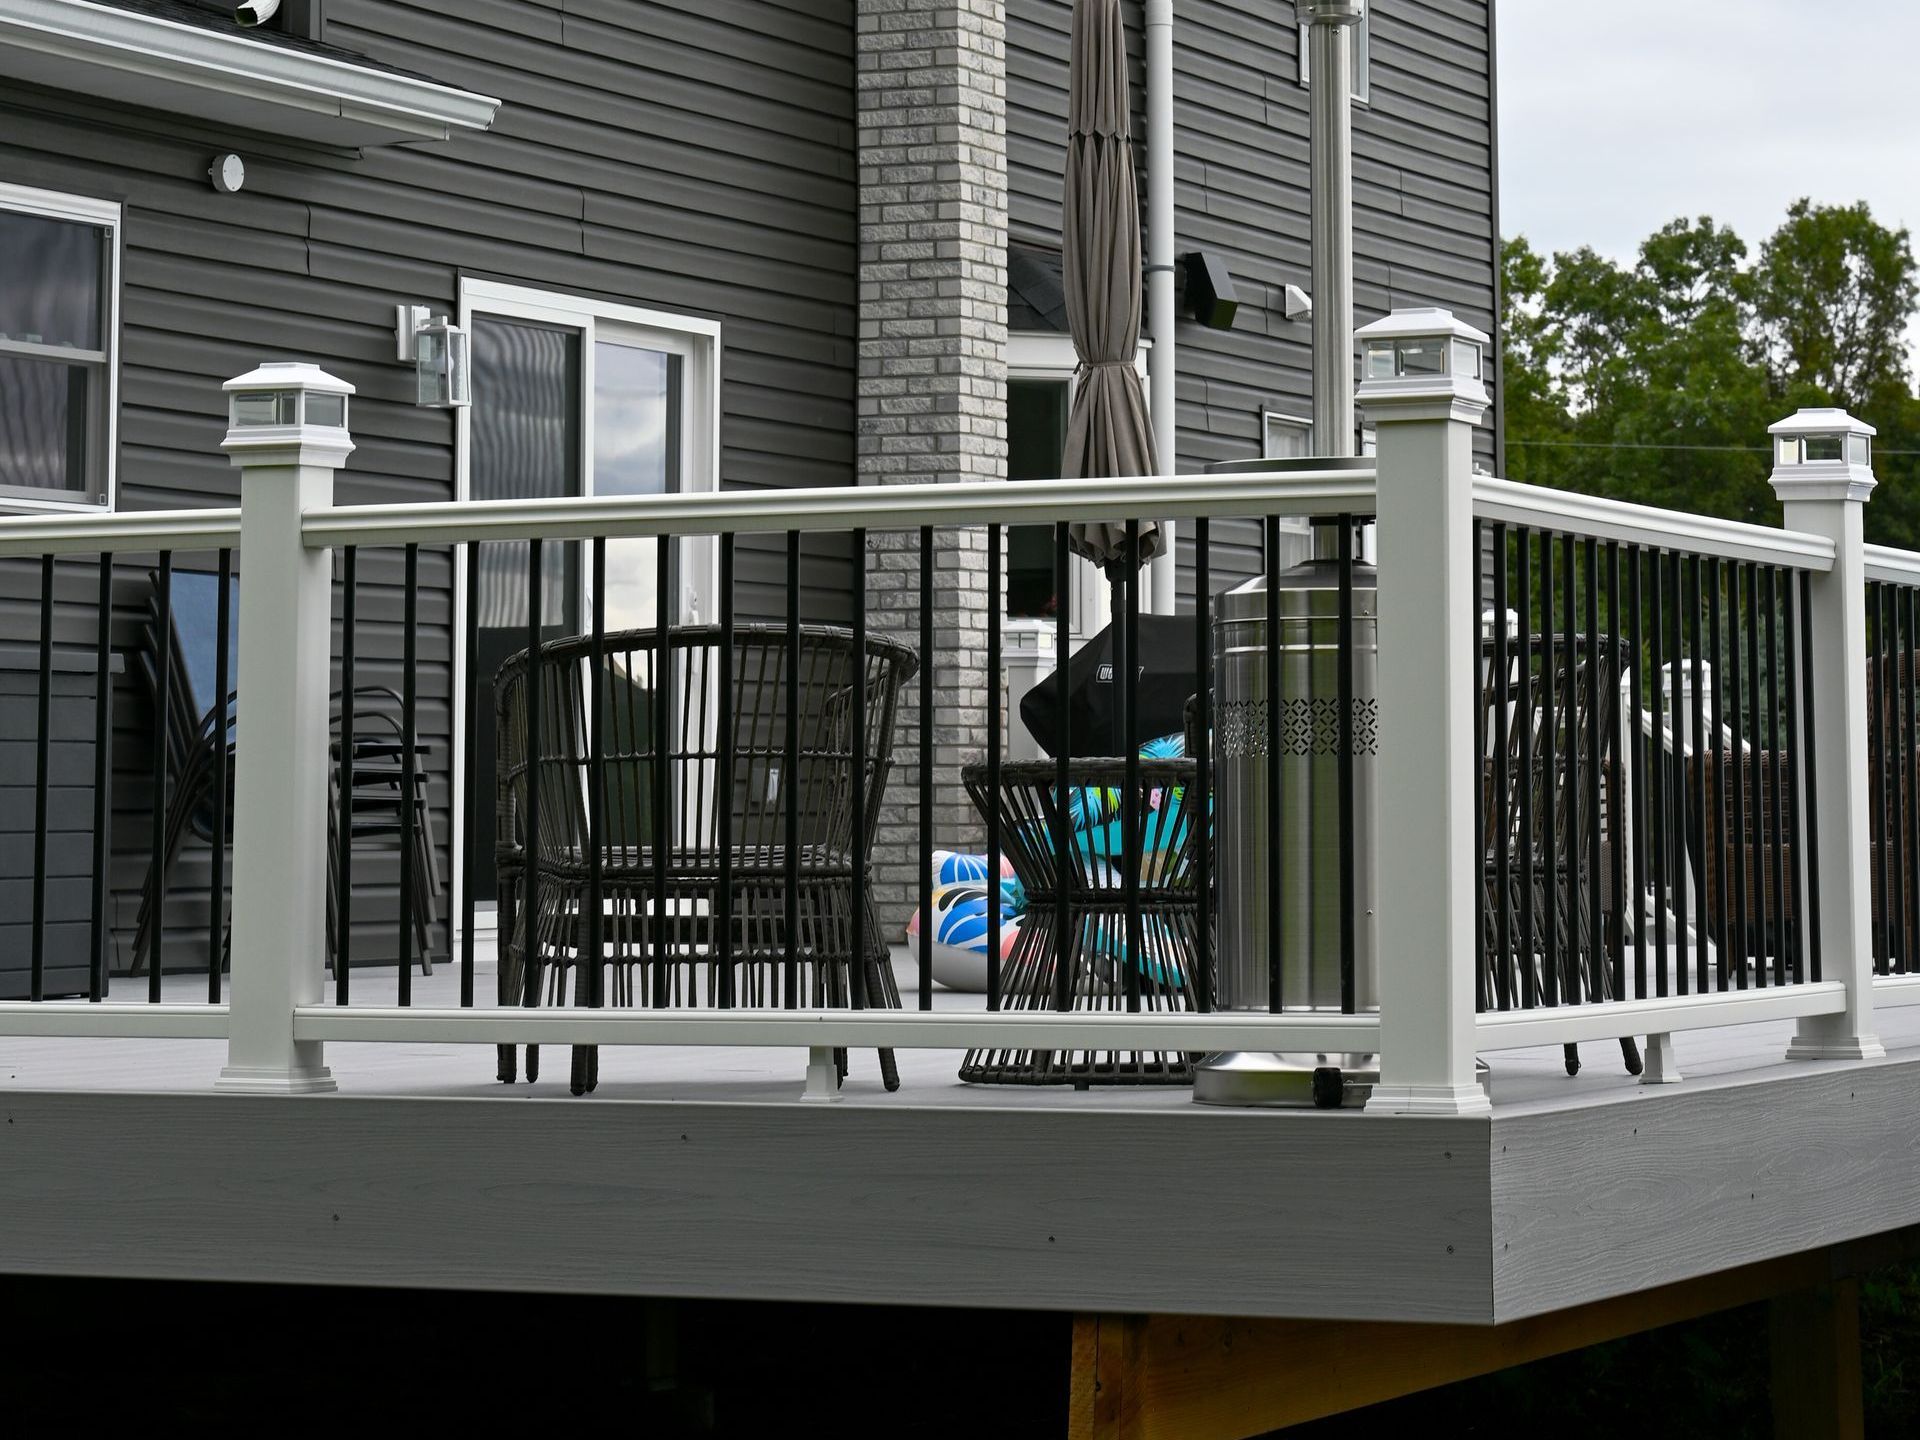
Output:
[{"xmin": 0, "ymin": 0, "xmax": 499, "ymax": 146}]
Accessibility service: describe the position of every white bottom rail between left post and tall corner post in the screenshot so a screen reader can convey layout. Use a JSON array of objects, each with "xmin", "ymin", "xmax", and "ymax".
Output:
[{"xmin": 294, "ymin": 1004, "xmax": 1380, "ymax": 1054}]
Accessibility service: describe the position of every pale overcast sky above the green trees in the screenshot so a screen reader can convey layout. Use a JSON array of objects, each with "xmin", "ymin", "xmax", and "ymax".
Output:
[{"xmin": 1498, "ymin": 0, "xmax": 1920, "ymax": 270}]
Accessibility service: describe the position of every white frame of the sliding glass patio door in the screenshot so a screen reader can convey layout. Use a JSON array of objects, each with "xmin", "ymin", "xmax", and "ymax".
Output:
[{"xmin": 449, "ymin": 278, "xmax": 722, "ymax": 952}]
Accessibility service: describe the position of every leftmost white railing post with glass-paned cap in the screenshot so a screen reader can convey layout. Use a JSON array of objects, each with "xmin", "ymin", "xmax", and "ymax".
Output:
[{"xmin": 219, "ymin": 365, "xmax": 353, "ymax": 1094}]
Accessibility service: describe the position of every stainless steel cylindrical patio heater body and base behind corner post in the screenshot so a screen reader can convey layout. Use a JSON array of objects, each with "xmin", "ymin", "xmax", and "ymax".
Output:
[{"xmin": 1194, "ymin": 459, "xmax": 1379, "ymax": 1108}]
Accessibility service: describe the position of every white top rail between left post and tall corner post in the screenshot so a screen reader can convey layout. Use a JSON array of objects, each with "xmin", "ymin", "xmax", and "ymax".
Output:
[{"xmin": 305, "ymin": 470, "xmax": 1375, "ymax": 545}]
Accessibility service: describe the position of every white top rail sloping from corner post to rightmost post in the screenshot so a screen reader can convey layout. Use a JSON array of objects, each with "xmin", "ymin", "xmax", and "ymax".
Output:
[{"xmin": 1473, "ymin": 474, "xmax": 1834, "ymax": 572}]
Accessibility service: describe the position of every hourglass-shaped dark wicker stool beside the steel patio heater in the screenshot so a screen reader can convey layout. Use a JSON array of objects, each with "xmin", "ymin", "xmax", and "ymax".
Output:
[{"xmin": 960, "ymin": 758, "xmax": 1204, "ymax": 1089}]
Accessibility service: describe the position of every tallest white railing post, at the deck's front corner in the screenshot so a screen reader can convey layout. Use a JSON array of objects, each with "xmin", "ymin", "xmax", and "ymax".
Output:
[{"xmin": 1357, "ymin": 309, "xmax": 1490, "ymax": 1116}]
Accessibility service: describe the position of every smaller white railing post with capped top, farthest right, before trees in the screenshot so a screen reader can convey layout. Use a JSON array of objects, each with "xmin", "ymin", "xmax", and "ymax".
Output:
[{"xmin": 1768, "ymin": 409, "xmax": 1885, "ymax": 1060}]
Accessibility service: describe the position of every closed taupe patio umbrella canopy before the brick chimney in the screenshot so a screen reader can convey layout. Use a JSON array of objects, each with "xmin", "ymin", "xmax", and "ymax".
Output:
[{"xmin": 1062, "ymin": 0, "xmax": 1164, "ymax": 576}]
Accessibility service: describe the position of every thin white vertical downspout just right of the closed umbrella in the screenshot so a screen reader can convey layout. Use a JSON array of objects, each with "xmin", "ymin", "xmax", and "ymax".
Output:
[{"xmin": 1146, "ymin": 0, "xmax": 1179, "ymax": 614}]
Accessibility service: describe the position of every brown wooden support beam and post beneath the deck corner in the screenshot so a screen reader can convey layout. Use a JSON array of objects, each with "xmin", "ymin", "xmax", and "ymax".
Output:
[{"xmin": 1068, "ymin": 1250, "xmax": 1885, "ymax": 1440}]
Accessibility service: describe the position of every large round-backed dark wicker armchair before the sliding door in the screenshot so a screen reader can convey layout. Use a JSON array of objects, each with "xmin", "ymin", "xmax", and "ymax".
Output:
[{"xmin": 493, "ymin": 626, "xmax": 918, "ymax": 1094}]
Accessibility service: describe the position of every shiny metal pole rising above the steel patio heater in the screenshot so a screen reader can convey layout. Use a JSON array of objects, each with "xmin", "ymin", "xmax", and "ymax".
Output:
[{"xmin": 1294, "ymin": 0, "xmax": 1367, "ymax": 457}]
